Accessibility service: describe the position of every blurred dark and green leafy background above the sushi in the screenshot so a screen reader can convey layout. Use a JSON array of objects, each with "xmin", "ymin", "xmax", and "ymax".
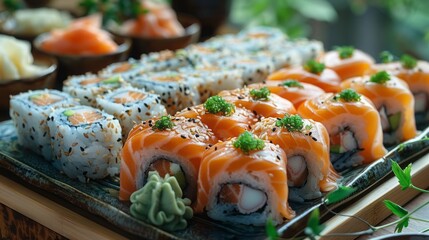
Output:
[{"xmin": 0, "ymin": 0, "xmax": 429, "ymax": 59}]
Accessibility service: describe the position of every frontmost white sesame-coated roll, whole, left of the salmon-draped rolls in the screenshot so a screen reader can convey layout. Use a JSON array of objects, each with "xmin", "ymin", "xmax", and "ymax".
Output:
[{"xmin": 48, "ymin": 106, "xmax": 122, "ymax": 182}]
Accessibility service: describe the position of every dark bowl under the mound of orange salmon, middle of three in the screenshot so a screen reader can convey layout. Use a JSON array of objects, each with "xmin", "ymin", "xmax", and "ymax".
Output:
[{"xmin": 33, "ymin": 33, "xmax": 131, "ymax": 88}]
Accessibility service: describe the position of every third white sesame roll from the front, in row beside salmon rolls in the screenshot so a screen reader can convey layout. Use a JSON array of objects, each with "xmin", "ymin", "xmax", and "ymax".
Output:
[{"xmin": 130, "ymin": 71, "xmax": 200, "ymax": 115}]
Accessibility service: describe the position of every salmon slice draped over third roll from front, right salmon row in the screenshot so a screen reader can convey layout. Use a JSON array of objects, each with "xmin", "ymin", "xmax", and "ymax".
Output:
[{"xmin": 298, "ymin": 93, "xmax": 387, "ymax": 169}]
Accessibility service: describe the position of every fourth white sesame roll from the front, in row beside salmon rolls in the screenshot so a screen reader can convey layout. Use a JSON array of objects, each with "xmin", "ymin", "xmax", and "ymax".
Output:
[{"xmin": 179, "ymin": 64, "xmax": 243, "ymax": 102}]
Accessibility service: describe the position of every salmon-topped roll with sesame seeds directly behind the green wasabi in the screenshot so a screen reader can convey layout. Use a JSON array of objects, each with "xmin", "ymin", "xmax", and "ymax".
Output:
[{"xmin": 119, "ymin": 116, "xmax": 217, "ymax": 201}]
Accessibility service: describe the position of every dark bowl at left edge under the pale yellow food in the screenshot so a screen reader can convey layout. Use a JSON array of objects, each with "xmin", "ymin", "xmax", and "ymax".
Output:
[{"xmin": 0, "ymin": 54, "xmax": 57, "ymax": 119}]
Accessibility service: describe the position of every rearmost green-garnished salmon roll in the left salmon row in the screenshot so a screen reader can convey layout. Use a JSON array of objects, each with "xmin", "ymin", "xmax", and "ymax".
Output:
[{"xmin": 321, "ymin": 46, "xmax": 374, "ymax": 80}]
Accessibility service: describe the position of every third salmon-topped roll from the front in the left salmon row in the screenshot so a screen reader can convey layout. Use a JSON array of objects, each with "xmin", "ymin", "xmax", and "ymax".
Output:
[{"xmin": 218, "ymin": 87, "xmax": 296, "ymax": 118}]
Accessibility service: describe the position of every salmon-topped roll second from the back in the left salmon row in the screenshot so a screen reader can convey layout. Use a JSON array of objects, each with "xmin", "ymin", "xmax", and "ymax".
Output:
[{"xmin": 267, "ymin": 60, "xmax": 341, "ymax": 92}]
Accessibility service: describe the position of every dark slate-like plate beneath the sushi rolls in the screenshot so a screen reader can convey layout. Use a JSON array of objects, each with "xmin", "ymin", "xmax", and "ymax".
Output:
[{"xmin": 0, "ymin": 121, "xmax": 429, "ymax": 239}]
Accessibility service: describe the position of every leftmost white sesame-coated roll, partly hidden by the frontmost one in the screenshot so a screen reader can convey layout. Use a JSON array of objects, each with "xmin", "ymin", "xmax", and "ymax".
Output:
[{"xmin": 10, "ymin": 89, "xmax": 78, "ymax": 161}]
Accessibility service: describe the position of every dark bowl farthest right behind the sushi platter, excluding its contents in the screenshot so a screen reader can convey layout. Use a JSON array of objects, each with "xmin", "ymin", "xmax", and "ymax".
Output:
[{"xmin": 110, "ymin": 14, "xmax": 201, "ymax": 58}]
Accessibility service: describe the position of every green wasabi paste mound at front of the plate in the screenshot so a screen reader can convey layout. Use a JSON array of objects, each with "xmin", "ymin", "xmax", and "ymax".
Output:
[{"xmin": 130, "ymin": 171, "xmax": 193, "ymax": 231}]
